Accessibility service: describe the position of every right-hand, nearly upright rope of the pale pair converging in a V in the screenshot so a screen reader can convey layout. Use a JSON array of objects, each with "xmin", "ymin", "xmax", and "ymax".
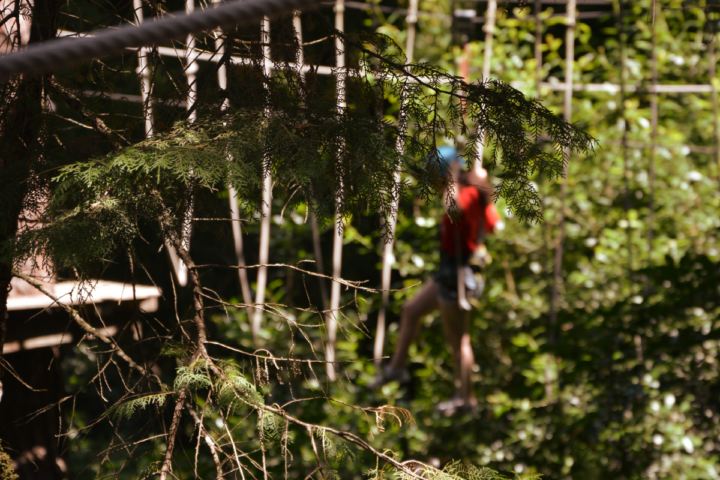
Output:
[{"xmin": 251, "ymin": 17, "xmax": 272, "ymax": 340}]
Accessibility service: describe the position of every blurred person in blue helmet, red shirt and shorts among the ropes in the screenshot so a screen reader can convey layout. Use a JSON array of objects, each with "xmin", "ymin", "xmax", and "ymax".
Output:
[{"xmin": 369, "ymin": 147, "xmax": 500, "ymax": 416}]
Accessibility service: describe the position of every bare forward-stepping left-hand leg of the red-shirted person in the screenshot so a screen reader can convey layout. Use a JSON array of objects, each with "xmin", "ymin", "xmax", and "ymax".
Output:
[{"xmin": 389, "ymin": 278, "xmax": 439, "ymax": 370}]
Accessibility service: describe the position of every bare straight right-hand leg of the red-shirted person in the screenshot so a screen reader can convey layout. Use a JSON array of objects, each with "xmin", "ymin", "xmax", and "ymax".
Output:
[{"xmin": 440, "ymin": 302, "xmax": 477, "ymax": 405}]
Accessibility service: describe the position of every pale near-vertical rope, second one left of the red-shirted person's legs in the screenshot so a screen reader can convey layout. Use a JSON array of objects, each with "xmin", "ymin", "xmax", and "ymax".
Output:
[{"xmin": 325, "ymin": 0, "xmax": 345, "ymax": 381}]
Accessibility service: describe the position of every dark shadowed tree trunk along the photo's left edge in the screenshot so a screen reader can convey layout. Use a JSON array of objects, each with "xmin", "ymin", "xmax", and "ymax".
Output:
[{"xmin": 0, "ymin": 0, "xmax": 66, "ymax": 480}]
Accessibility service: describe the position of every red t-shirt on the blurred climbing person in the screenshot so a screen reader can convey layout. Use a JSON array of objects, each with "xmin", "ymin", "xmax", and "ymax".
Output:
[{"xmin": 440, "ymin": 186, "xmax": 500, "ymax": 255}]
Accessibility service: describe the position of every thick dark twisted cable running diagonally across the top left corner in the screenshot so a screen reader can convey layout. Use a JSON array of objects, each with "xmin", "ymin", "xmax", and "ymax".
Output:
[{"xmin": 0, "ymin": 0, "xmax": 320, "ymax": 80}]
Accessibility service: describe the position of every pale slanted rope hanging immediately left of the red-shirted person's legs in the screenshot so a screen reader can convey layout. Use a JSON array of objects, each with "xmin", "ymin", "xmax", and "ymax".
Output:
[{"xmin": 373, "ymin": 0, "xmax": 418, "ymax": 374}]
